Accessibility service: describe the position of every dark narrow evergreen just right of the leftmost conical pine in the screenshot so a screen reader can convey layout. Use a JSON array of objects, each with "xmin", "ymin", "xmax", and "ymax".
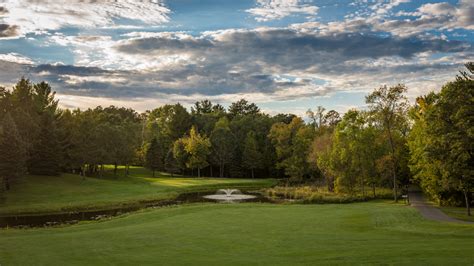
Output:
[{"xmin": 28, "ymin": 113, "xmax": 62, "ymax": 176}]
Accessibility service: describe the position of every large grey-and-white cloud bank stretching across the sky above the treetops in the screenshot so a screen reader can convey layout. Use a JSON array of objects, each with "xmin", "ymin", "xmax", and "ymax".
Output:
[{"xmin": 30, "ymin": 26, "xmax": 473, "ymax": 106}]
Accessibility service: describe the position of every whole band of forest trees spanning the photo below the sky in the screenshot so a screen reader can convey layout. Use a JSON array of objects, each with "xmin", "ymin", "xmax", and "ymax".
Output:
[{"xmin": 0, "ymin": 63, "xmax": 474, "ymax": 213}]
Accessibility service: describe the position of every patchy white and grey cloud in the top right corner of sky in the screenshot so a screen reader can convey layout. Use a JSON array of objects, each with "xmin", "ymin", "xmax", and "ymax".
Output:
[{"xmin": 290, "ymin": 0, "xmax": 474, "ymax": 38}]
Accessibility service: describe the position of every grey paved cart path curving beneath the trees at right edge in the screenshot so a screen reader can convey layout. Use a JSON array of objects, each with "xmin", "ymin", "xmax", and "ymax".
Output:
[{"xmin": 408, "ymin": 192, "xmax": 474, "ymax": 224}]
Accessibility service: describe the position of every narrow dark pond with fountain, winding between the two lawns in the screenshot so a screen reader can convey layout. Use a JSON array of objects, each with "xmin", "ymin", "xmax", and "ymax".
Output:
[{"xmin": 0, "ymin": 191, "xmax": 273, "ymax": 228}]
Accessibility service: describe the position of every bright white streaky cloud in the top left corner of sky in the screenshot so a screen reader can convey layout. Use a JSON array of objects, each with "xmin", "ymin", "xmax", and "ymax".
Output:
[{"xmin": 0, "ymin": 0, "xmax": 170, "ymax": 36}]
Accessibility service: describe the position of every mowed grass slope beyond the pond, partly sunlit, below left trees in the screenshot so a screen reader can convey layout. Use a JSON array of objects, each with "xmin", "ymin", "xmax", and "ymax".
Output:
[{"xmin": 0, "ymin": 167, "xmax": 276, "ymax": 216}]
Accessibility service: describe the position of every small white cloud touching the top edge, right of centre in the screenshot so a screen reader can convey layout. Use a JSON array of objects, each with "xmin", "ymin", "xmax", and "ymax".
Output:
[{"xmin": 246, "ymin": 0, "xmax": 319, "ymax": 22}]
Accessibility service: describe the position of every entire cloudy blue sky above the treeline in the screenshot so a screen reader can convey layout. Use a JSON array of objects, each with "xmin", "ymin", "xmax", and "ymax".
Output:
[{"xmin": 0, "ymin": 0, "xmax": 474, "ymax": 114}]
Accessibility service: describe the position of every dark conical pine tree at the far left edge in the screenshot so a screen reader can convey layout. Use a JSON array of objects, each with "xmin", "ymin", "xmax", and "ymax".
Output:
[{"xmin": 0, "ymin": 113, "xmax": 27, "ymax": 190}]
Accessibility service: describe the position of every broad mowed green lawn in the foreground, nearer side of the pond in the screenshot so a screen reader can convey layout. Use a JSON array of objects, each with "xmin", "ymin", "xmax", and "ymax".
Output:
[{"xmin": 0, "ymin": 201, "xmax": 474, "ymax": 265}]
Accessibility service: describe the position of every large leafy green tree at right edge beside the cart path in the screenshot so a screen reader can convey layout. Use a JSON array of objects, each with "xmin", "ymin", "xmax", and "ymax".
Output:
[{"xmin": 409, "ymin": 64, "xmax": 474, "ymax": 215}]
